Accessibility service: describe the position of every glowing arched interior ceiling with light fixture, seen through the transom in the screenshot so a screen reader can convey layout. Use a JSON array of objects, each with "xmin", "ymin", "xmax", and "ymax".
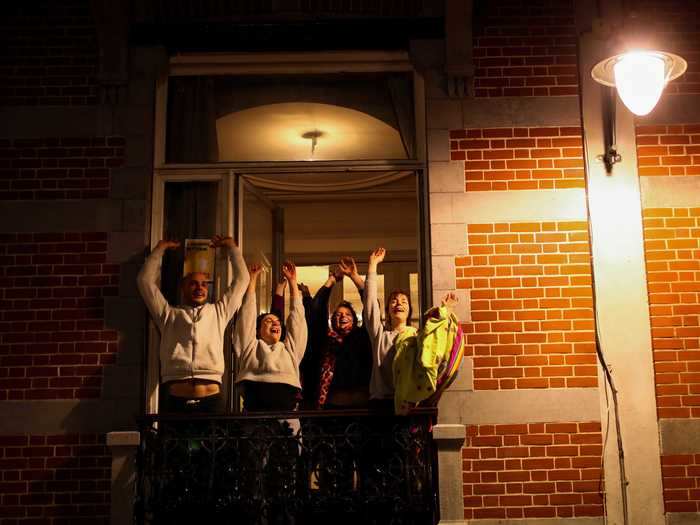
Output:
[{"xmin": 216, "ymin": 102, "xmax": 407, "ymax": 161}]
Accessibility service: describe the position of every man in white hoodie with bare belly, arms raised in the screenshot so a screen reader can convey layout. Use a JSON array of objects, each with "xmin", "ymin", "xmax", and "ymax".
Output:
[{"xmin": 137, "ymin": 235, "xmax": 250, "ymax": 413}]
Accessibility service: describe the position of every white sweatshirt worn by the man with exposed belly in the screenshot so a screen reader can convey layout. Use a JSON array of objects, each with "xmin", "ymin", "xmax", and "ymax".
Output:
[{"xmin": 136, "ymin": 247, "xmax": 250, "ymax": 383}]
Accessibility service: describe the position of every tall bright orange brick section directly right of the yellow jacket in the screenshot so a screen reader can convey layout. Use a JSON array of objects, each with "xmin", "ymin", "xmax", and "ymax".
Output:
[{"xmin": 455, "ymin": 221, "xmax": 597, "ymax": 390}]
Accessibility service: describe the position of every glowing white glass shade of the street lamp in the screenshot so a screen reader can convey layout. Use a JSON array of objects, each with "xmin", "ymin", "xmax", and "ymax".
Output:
[{"xmin": 613, "ymin": 51, "xmax": 666, "ymax": 116}]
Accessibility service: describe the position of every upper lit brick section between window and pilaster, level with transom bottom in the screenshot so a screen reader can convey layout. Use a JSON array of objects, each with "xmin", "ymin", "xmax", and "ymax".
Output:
[{"xmin": 450, "ymin": 127, "xmax": 585, "ymax": 191}]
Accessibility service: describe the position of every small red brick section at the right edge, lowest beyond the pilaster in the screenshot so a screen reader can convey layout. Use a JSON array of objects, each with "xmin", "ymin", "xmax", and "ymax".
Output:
[{"xmin": 661, "ymin": 454, "xmax": 700, "ymax": 512}]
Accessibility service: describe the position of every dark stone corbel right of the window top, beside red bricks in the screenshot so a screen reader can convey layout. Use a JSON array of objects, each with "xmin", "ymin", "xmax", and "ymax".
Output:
[{"xmin": 445, "ymin": 0, "xmax": 474, "ymax": 98}]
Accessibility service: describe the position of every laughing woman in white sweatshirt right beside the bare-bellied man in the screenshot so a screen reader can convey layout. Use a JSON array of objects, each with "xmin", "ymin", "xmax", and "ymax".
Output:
[{"xmin": 233, "ymin": 261, "xmax": 308, "ymax": 412}]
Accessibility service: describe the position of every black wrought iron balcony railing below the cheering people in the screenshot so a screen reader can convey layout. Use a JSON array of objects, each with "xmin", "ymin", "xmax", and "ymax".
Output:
[{"xmin": 135, "ymin": 409, "xmax": 437, "ymax": 525}]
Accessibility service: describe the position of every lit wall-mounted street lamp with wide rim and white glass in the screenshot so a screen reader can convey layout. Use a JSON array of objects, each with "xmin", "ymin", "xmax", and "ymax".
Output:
[{"xmin": 591, "ymin": 50, "xmax": 688, "ymax": 116}]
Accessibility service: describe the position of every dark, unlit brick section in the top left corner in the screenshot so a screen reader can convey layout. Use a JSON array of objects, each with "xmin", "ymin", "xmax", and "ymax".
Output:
[{"xmin": 0, "ymin": 0, "xmax": 97, "ymax": 107}]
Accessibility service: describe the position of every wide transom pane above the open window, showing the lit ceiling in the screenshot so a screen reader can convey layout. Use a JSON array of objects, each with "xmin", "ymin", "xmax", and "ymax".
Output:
[{"xmin": 166, "ymin": 73, "xmax": 415, "ymax": 163}]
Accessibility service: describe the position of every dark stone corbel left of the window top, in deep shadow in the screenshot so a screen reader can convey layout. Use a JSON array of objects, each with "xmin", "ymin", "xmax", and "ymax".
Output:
[{"xmin": 90, "ymin": 0, "xmax": 129, "ymax": 105}]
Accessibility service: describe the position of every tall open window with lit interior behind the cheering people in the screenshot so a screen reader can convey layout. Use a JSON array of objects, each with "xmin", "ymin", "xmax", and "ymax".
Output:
[{"xmin": 146, "ymin": 52, "xmax": 431, "ymax": 412}]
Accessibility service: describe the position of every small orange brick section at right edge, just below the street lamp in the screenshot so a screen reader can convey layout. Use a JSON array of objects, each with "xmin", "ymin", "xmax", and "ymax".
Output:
[{"xmin": 636, "ymin": 124, "xmax": 700, "ymax": 176}]
